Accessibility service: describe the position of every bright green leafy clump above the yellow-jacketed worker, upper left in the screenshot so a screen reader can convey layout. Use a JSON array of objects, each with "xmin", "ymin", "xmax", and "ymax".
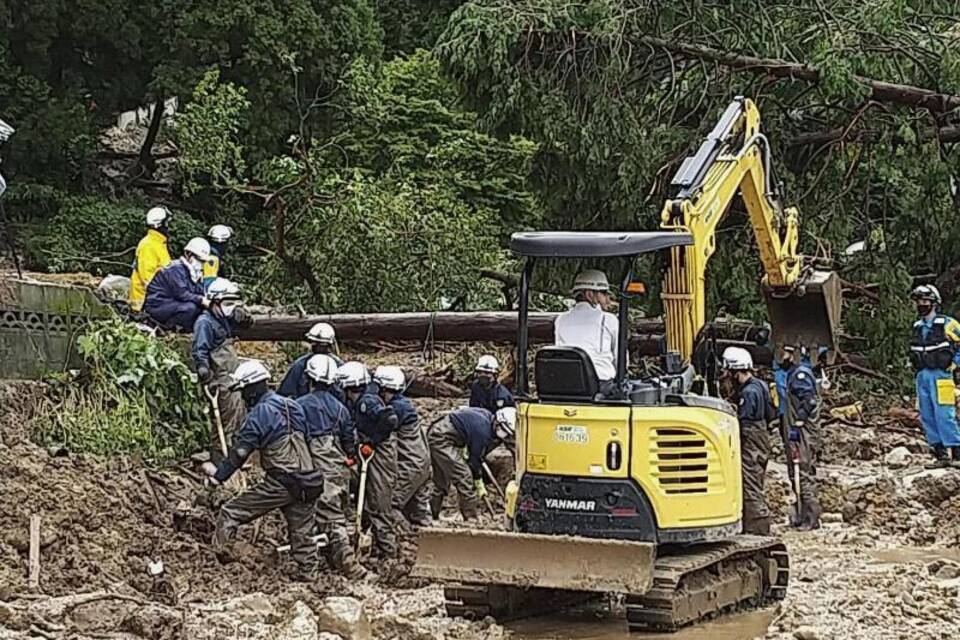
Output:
[{"xmin": 175, "ymin": 68, "xmax": 250, "ymax": 195}]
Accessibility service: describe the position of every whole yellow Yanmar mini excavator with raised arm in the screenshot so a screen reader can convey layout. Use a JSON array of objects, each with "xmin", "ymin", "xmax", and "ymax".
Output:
[{"xmin": 413, "ymin": 97, "xmax": 840, "ymax": 631}]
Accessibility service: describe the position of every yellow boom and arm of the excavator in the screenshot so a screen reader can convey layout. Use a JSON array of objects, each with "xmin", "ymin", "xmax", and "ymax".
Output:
[{"xmin": 661, "ymin": 97, "xmax": 839, "ymax": 360}]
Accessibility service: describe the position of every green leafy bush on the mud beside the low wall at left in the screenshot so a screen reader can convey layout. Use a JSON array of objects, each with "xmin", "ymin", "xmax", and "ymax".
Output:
[{"xmin": 40, "ymin": 319, "xmax": 209, "ymax": 460}]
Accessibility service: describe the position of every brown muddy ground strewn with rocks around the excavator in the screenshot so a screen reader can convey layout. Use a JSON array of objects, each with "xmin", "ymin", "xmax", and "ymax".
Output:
[{"xmin": 0, "ymin": 352, "xmax": 960, "ymax": 640}]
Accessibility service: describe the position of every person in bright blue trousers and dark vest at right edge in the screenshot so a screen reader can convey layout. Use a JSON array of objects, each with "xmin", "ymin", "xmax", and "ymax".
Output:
[{"xmin": 910, "ymin": 285, "xmax": 960, "ymax": 468}]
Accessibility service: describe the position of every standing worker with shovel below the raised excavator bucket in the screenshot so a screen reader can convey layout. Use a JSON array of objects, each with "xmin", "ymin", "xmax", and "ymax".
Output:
[{"xmin": 780, "ymin": 346, "xmax": 823, "ymax": 531}]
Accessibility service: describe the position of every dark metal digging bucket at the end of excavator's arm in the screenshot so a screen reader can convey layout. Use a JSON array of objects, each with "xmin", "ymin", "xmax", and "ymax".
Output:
[{"xmin": 764, "ymin": 271, "xmax": 842, "ymax": 362}]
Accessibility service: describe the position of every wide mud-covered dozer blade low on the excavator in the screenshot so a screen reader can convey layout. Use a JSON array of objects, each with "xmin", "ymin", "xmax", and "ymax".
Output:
[{"xmin": 411, "ymin": 528, "xmax": 656, "ymax": 594}]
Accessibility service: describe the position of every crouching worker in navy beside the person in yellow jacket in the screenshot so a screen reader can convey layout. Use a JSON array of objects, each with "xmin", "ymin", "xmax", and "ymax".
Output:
[{"xmin": 143, "ymin": 238, "xmax": 210, "ymax": 332}]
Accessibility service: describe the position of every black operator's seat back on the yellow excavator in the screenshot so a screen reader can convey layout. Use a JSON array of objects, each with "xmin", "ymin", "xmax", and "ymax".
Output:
[{"xmin": 534, "ymin": 347, "xmax": 600, "ymax": 402}]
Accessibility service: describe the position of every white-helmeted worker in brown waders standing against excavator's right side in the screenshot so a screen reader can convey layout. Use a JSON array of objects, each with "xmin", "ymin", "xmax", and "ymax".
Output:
[{"xmin": 723, "ymin": 347, "xmax": 776, "ymax": 535}]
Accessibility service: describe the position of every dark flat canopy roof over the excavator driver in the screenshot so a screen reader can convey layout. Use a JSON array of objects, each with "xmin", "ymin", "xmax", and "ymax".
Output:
[{"xmin": 510, "ymin": 231, "xmax": 693, "ymax": 258}]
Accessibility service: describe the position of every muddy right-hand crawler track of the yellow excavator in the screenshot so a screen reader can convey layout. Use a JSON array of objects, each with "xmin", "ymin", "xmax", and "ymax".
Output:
[{"xmin": 626, "ymin": 535, "xmax": 790, "ymax": 631}]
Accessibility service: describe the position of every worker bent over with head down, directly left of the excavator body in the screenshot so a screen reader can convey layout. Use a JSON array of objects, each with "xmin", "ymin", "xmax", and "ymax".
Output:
[{"xmin": 427, "ymin": 407, "xmax": 517, "ymax": 520}]
